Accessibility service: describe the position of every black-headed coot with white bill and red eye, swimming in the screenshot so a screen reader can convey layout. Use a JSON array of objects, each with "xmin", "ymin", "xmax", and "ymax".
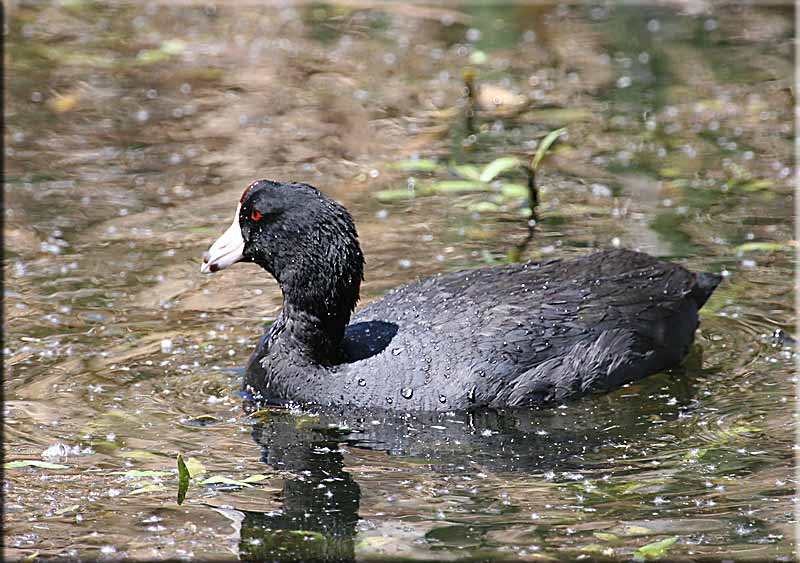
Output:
[{"xmin": 201, "ymin": 180, "xmax": 720, "ymax": 411}]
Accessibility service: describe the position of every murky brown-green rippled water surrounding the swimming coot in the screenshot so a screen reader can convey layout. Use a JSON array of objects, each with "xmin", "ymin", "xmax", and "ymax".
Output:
[{"xmin": 3, "ymin": 1, "xmax": 796, "ymax": 561}]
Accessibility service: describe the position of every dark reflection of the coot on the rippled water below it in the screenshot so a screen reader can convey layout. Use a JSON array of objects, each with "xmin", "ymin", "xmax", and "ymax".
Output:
[{"xmin": 234, "ymin": 370, "xmax": 693, "ymax": 562}]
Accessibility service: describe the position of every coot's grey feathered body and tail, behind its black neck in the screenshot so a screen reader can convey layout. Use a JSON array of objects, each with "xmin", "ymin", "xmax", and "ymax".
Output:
[{"xmin": 336, "ymin": 250, "xmax": 719, "ymax": 410}]
